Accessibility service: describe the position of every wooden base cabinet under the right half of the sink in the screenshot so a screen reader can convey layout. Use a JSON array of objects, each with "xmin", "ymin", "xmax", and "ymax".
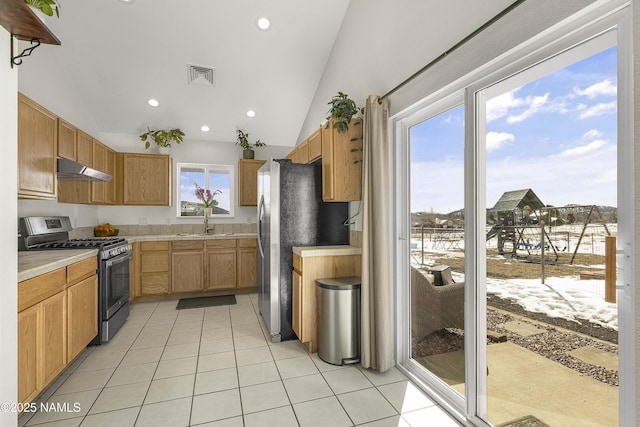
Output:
[{"xmin": 207, "ymin": 239, "xmax": 237, "ymax": 290}]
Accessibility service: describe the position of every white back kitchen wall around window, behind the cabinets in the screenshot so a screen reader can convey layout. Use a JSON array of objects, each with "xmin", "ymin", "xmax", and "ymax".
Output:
[{"xmin": 18, "ymin": 132, "xmax": 291, "ymax": 227}]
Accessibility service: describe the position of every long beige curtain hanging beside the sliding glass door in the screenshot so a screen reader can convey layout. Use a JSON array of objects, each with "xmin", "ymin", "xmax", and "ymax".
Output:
[{"xmin": 360, "ymin": 96, "xmax": 394, "ymax": 372}]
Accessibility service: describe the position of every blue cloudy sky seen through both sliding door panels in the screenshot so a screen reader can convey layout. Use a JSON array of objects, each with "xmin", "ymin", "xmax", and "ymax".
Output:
[{"xmin": 411, "ymin": 48, "xmax": 617, "ymax": 213}]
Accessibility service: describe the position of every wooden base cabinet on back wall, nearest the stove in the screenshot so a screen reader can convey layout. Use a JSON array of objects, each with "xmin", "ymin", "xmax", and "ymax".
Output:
[{"xmin": 140, "ymin": 242, "xmax": 170, "ymax": 295}]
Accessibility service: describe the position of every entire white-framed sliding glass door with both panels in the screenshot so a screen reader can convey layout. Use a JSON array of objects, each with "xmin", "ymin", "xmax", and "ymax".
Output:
[{"xmin": 394, "ymin": 8, "xmax": 634, "ymax": 426}]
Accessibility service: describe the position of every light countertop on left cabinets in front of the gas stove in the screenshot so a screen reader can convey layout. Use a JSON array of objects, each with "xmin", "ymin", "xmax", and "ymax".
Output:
[{"xmin": 18, "ymin": 249, "xmax": 98, "ymax": 282}]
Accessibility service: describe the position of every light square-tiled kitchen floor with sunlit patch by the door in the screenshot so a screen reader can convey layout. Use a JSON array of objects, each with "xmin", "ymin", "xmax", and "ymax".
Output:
[{"xmin": 19, "ymin": 294, "xmax": 460, "ymax": 427}]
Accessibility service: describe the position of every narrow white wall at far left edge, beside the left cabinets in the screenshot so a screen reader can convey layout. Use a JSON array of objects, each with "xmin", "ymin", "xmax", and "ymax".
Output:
[{"xmin": 0, "ymin": 27, "xmax": 18, "ymax": 426}]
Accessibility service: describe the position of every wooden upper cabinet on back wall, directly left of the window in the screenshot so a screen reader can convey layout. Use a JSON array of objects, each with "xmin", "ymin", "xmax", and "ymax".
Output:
[{"xmin": 116, "ymin": 153, "xmax": 173, "ymax": 206}]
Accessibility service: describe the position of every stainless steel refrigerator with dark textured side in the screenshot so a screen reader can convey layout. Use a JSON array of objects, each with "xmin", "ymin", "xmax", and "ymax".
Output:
[{"xmin": 258, "ymin": 159, "xmax": 349, "ymax": 342}]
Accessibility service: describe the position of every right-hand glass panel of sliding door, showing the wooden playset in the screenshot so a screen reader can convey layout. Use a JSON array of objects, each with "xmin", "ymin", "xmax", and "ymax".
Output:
[{"xmin": 475, "ymin": 36, "xmax": 618, "ymax": 427}]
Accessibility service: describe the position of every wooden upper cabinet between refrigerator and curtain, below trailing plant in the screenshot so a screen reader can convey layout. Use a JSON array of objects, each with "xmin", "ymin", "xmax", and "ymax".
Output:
[{"xmin": 321, "ymin": 119, "xmax": 362, "ymax": 202}]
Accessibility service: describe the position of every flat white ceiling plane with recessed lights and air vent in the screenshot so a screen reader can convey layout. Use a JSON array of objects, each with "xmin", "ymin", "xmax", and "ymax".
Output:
[{"xmin": 19, "ymin": 0, "xmax": 349, "ymax": 146}]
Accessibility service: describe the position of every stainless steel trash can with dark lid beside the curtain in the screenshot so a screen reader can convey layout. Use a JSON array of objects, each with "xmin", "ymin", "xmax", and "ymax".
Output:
[{"xmin": 316, "ymin": 277, "xmax": 360, "ymax": 365}]
